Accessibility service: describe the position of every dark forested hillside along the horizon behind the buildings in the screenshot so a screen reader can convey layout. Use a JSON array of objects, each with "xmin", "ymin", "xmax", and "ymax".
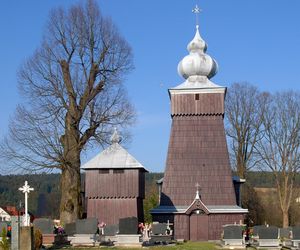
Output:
[{"xmin": 0, "ymin": 172, "xmax": 292, "ymax": 218}]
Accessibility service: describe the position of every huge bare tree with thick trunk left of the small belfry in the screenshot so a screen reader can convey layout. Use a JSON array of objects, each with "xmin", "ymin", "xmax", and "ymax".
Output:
[{"xmin": 1, "ymin": 0, "xmax": 134, "ymax": 223}]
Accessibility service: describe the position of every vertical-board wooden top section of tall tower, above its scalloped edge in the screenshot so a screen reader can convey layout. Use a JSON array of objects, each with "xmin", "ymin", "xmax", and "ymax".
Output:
[{"xmin": 171, "ymin": 93, "xmax": 224, "ymax": 116}]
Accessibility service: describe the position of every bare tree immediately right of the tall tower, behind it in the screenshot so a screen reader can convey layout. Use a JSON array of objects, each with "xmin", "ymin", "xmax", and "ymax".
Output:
[{"xmin": 225, "ymin": 83, "xmax": 268, "ymax": 178}]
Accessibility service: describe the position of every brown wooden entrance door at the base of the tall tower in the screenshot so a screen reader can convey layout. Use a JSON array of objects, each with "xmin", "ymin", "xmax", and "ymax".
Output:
[{"xmin": 190, "ymin": 210, "xmax": 208, "ymax": 241}]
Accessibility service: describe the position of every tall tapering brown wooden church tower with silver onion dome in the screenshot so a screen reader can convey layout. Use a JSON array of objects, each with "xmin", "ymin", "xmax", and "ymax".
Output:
[{"xmin": 151, "ymin": 15, "xmax": 248, "ymax": 241}]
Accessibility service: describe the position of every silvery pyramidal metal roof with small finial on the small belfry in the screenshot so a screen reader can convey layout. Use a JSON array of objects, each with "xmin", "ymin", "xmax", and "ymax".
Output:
[{"xmin": 81, "ymin": 130, "xmax": 148, "ymax": 172}]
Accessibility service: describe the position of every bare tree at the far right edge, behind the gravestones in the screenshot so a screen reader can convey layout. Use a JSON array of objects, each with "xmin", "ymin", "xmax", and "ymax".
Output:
[{"xmin": 257, "ymin": 92, "xmax": 300, "ymax": 227}]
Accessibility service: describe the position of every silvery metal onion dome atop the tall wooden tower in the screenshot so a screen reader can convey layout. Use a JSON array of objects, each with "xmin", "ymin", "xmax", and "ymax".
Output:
[{"xmin": 178, "ymin": 25, "xmax": 218, "ymax": 79}]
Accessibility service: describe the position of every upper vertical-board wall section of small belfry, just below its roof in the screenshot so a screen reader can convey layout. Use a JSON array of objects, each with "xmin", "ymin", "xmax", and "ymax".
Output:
[{"xmin": 85, "ymin": 169, "xmax": 145, "ymax": 199}]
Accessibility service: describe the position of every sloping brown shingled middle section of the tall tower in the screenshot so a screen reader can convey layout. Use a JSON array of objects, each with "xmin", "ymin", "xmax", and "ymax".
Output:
[{"xmin": 160, "ymin": 115, "xmax": 236, "ymax": 206}]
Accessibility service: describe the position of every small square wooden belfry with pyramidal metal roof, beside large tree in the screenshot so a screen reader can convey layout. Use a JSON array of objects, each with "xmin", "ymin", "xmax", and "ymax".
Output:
[{"xmin": 81, "ymin": 130, "xmax": 148, "ymax": 225}]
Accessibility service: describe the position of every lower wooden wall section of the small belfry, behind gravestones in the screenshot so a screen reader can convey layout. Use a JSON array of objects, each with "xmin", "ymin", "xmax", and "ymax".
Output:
[{"xmin": 87, "ymin": 198, "xmax": 144, "ymax": 225}]
